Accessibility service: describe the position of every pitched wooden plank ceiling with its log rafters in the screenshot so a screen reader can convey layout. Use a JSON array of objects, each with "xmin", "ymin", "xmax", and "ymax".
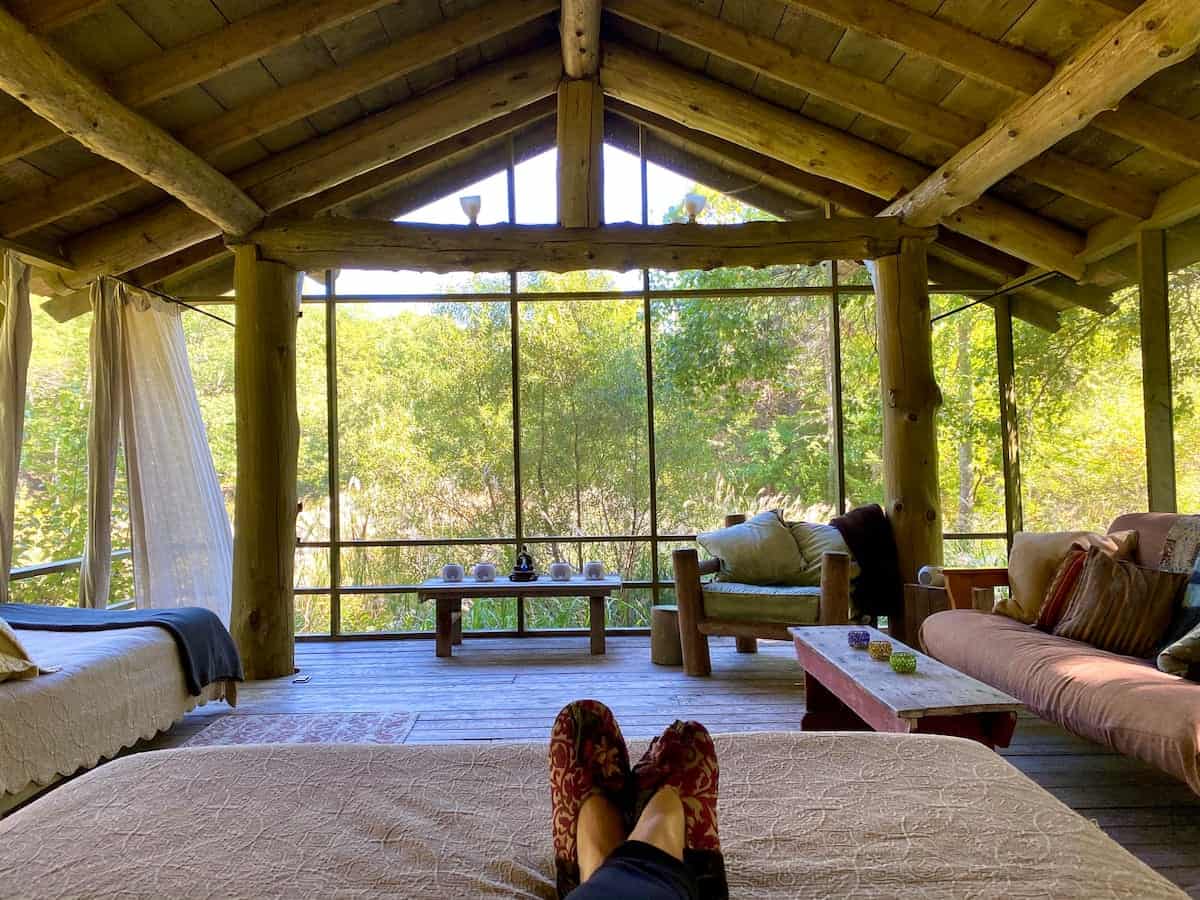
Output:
[{"xmin": 0, "ymin": 0, "xmax": 1200, "ymax": 328}]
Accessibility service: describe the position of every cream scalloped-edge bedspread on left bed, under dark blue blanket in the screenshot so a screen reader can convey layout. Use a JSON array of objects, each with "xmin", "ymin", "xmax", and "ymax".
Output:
[{"xmin": 0, "ymin": 628, "xmax": 226, "ymax": 809}]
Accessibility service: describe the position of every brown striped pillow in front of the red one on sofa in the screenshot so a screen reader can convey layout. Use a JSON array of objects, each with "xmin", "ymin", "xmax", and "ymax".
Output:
[{"xmin": 1054, "ymin": 548, "xmax": 1188, "ymax": 659}]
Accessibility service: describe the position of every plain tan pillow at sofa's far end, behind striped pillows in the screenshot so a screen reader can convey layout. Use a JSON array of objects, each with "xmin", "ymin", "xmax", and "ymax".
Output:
[{"xmin": 992, "ymin": 532, "xmax": 1138, "ymax": 625}]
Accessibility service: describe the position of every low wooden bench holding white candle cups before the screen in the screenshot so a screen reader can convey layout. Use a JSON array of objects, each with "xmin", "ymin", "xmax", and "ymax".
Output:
[{"xmin": 416, "ymin": 575, "xmax": 622, "ymax": 656}]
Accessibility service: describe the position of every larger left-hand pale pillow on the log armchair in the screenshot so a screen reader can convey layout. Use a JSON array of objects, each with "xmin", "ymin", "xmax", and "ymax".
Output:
[{"xmin": 696, "ymin": 510, "xmax": 804, "ymax": 584}]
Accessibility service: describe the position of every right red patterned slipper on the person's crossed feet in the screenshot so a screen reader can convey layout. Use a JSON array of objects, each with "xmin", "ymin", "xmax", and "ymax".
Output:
[{"xmin": 634, "ymin": 721, "xmax": 730, "ymax": 900}]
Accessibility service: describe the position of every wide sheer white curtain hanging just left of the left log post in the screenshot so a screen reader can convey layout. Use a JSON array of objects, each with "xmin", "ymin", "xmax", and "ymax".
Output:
[{"xmin": 81, "ymin": 280, "xmax": 233, "ymax": 625}]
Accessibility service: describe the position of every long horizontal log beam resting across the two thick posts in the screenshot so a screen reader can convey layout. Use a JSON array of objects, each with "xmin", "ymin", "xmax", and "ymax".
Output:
[{"xmin": 246, "ymin": 218, "xmax": 935, "ymax": 272}]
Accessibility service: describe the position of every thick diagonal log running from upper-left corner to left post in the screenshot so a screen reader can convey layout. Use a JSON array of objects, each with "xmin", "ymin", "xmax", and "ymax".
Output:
[{"xmin": 0, "ymin": 8, "xmax": 264, "ymax": 234}]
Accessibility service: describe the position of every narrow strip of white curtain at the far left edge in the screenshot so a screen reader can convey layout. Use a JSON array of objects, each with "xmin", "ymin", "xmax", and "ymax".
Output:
[{"xmin": 0, "ymin": 252, "xmax": 34, "ymax": 602}]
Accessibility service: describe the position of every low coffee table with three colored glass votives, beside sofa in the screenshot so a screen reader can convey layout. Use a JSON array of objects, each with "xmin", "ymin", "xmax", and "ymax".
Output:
[{"xmin": 788, "ymin": 625, "xmax": 1021, "ymax": 748}]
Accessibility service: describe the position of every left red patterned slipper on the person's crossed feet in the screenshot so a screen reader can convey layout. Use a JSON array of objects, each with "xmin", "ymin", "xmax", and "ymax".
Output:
[{"xmin": 550, "ymin": 700, "xmax": 630, "ymax": 898}]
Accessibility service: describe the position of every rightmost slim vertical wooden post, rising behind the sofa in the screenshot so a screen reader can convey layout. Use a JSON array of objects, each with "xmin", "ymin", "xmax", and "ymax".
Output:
[{"xmin": 1138, "ymin": 230, "xmax": 1176, "ymax": 512}]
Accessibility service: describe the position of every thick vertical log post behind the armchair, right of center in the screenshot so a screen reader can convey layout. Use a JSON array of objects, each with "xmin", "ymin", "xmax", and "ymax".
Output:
[{"xmin": 875, "ymin": 239, "xmax": 942, "ymax": 583}]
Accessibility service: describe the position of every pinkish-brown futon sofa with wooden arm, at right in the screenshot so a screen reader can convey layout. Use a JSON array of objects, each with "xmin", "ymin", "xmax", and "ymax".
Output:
[{"xmin": 920, "ymin": 514, "xmax": 1200, "ymax": 794}]
